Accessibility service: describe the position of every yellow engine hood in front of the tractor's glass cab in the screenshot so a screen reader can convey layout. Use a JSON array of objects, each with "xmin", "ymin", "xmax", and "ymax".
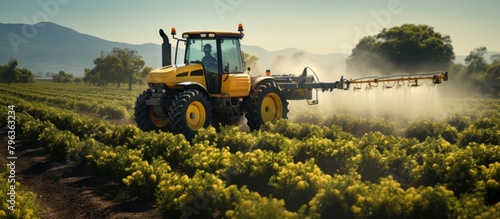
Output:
[{"xmin": 147, "ymin": 63, "xmax": 206, "ymax": 89}]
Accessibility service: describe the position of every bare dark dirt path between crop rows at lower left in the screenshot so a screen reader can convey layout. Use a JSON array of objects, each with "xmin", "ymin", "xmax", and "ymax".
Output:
[{"xmin": 0, "ymin": 129, "xmax": 161, "ymax": 219}]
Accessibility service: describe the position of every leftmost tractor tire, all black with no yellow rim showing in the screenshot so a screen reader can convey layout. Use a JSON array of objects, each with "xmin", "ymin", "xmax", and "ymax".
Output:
[{"xmin": 134, "ymin": 89, "xmax": 170, "ymax": 132}]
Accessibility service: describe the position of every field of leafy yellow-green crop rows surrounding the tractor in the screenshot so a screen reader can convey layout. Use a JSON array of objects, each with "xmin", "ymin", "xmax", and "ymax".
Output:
[{"xmin": 0, "ymin": 82, "xmax": 500, "ymax": 218}]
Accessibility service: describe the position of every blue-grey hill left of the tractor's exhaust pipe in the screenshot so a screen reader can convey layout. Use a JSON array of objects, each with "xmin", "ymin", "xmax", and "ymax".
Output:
[{"xmin": 0, "ymin": 22, "xmax": 161, "ymax": 76}]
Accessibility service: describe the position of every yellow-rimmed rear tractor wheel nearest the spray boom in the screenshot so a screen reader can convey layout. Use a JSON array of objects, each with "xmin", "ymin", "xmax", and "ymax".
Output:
[{"xmin": 244, "ymin": 81, "xmax": 288, "ymax": 130}]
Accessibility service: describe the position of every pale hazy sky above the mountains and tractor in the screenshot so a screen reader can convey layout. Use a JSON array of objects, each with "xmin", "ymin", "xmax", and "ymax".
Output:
[{"xmin": 0, "ymin": 0, "xmax": 500, "ymax": 55}]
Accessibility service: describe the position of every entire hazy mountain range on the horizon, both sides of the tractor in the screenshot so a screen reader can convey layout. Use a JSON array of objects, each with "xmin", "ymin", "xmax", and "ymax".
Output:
[{"xmin": 0, "ymin": 22, "xmax": 494, "ymax": 76}]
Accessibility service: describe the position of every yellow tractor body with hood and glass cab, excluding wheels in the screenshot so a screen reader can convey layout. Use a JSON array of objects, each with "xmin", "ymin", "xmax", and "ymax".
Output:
[{"xmin": 147, "ymin": 24, "xmax": 251, "ymax": 98}]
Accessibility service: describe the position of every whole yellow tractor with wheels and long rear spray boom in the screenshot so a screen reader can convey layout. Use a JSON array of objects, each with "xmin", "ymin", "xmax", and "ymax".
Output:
[{"xmin": 134, "ymin": 24, "xmax": 448, "ymax": 138}]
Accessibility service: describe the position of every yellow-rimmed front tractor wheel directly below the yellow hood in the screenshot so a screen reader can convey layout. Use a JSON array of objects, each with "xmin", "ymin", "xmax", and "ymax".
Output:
[{"xmin": 169, "ymin": 89, "xmax": 212, "ymax": 139}]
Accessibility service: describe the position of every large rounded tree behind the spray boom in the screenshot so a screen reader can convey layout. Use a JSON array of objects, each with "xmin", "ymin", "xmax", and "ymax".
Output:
[{"xmin": 347, "ymin": 24, "xmax": 455, "ymax": 74}]
